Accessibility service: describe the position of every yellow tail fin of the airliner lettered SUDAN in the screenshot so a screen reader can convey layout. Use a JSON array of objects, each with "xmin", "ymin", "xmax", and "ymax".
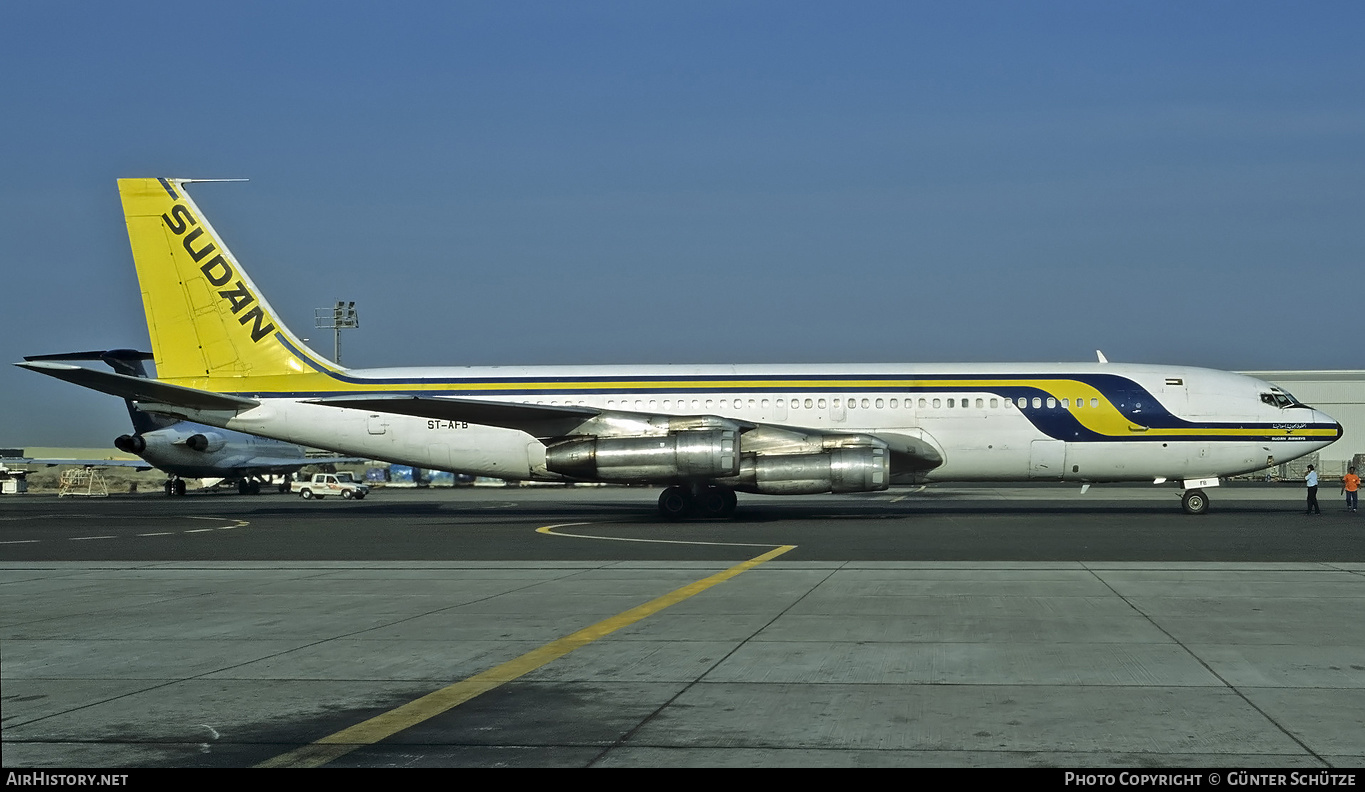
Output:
[{"xmin": 119, "ymin": 179, "xmax": 343, "ymax": 392}]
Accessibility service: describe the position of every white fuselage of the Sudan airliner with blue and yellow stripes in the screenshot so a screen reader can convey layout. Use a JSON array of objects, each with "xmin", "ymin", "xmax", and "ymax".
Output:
[{"xmin": 162, "ymin": 363, "xmax": 1340, "ymax": 483}]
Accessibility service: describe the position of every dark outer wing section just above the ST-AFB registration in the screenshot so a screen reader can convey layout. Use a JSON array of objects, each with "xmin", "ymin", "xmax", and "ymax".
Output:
[{"xmin": 308, "ymin": 395, "xmax": 602, "ymax": 437}]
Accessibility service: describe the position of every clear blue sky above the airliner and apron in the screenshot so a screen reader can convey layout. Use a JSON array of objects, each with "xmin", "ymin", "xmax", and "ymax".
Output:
[{"xmin": 0, "ymin": 0, "xmax": 1365, "ymax": 447}]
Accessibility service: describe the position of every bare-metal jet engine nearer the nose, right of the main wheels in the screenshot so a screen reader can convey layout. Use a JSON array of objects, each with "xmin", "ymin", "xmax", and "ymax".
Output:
[{"xmin": 719, "ymin": 447, "xmax": 891, "ymax": 494}]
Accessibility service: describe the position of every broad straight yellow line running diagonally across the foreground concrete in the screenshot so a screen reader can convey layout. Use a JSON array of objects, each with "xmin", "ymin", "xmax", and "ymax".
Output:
[{"xmin": 257, "ymin": 545, "xmax": 796, "ymax": 767}]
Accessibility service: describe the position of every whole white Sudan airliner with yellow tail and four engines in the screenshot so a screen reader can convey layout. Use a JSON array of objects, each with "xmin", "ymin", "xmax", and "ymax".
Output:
[{"xmin": 18, "ymin": 179, "xmax": 1342, "ymax": 519}]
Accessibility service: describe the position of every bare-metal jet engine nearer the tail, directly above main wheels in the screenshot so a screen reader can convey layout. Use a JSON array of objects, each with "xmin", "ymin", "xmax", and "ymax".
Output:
[{"xmin": 545, "ymin": 429, "xmax": 740, "ymax": 483}]
